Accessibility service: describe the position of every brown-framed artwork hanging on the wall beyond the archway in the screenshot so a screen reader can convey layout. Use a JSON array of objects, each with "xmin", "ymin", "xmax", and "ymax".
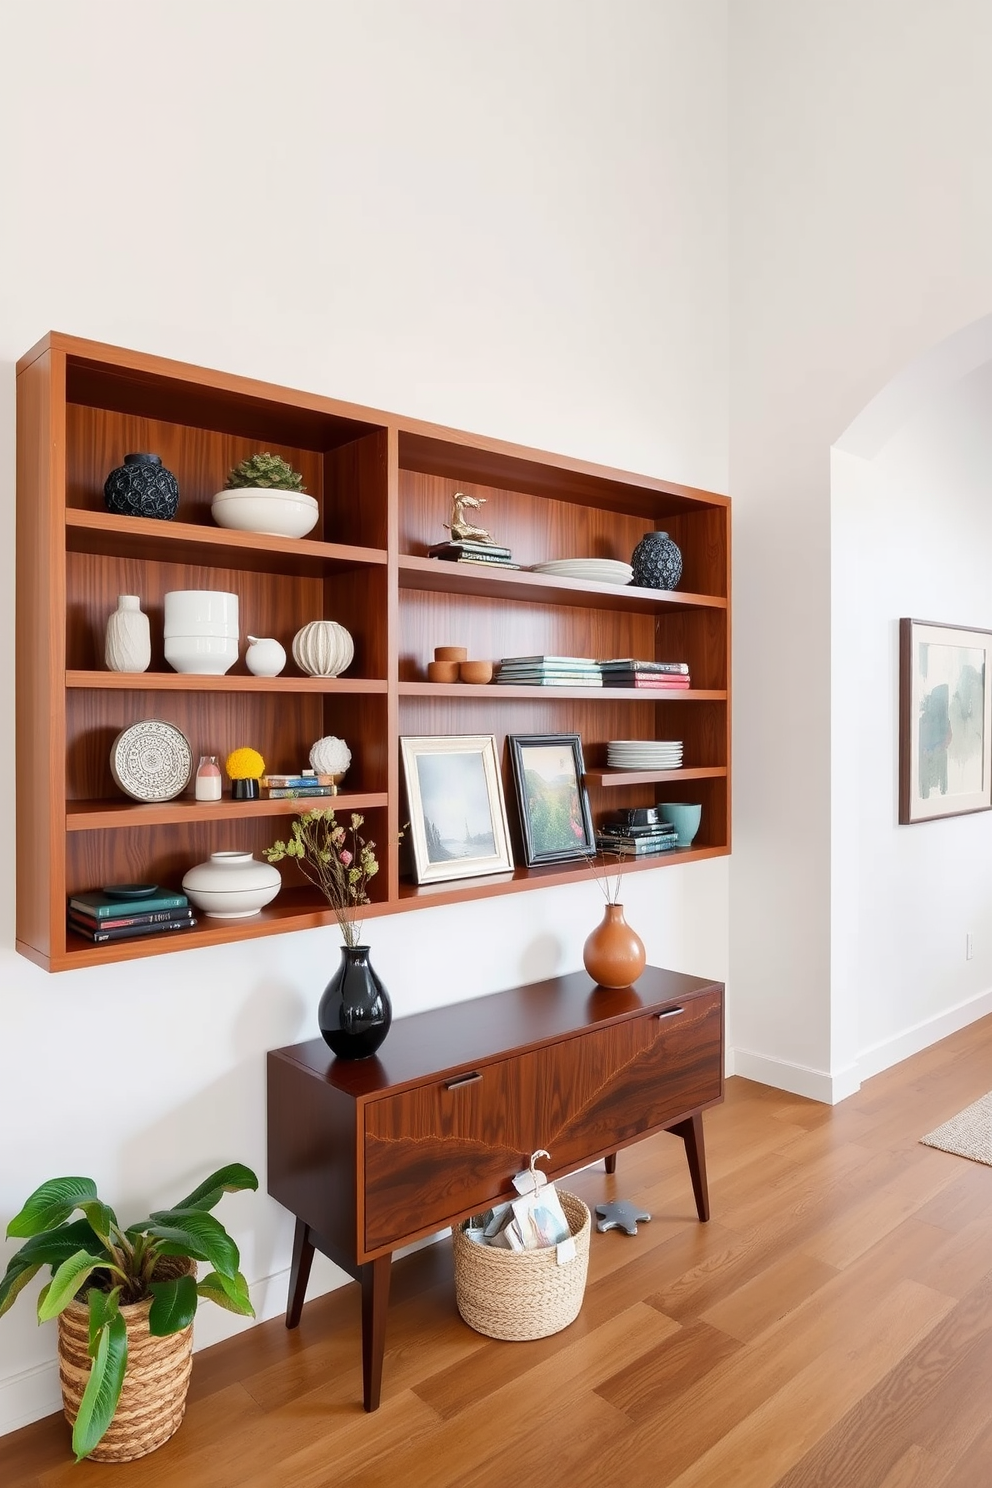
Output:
[{"xmin": 898, "ymin": 619, "xmax": 992, "ymax": 826}]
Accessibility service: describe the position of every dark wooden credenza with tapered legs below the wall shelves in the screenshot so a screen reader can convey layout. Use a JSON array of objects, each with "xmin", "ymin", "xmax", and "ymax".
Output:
[{"xmin": 268, "ymin": 966, "xmax": 723, "ymax": 1411}]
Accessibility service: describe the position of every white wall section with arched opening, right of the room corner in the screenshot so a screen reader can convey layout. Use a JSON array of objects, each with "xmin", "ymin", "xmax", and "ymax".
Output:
[{"xmin": 729, "ymin": 0, "xmax": 992, "ymax": 1100}]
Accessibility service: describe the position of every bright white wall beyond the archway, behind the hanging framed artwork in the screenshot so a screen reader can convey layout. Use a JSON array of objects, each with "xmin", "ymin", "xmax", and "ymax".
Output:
[{"xmin": 831, "ymin": 363, "xmax": 992, "ymax": 1079}]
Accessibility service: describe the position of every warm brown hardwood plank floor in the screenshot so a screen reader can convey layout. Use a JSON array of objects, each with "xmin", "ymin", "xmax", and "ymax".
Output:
[{"xmin": 0, "ymin": 1018, "xmax": 992, "ymax": 1488}]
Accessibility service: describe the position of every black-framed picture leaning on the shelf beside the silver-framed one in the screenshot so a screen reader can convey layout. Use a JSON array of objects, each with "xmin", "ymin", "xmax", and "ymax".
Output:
[{"xmin": 507, "ymin": 734, "xmax": 596, "ymax": 868}]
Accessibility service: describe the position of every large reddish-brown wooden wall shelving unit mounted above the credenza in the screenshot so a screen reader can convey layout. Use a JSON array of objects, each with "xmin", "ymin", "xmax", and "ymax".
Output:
[{"xmin": 16, "ymin": 332, "xmax": 730, "ymax": 970}]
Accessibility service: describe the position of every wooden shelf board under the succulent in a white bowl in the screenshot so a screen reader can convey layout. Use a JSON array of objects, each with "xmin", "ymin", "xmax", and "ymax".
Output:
[{"xmin": 65, "ymin": 506, "xmax": 387, "ymax": 577}]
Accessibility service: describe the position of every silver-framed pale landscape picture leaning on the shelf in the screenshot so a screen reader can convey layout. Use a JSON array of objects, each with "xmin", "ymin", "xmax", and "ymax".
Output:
[{"xmin": 400, "ymin": 734, "xmax": 513, "ymax": 884}]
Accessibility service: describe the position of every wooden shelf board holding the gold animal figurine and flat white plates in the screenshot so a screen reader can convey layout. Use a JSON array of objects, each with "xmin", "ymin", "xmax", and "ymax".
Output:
[{"xmin": 399, "ymin": 554, "xmax": 727, "ymax": 615}]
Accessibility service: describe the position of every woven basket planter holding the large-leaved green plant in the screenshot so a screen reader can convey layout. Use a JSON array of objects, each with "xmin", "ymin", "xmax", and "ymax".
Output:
[{"xmin": 58, "ymin": 1256, "xmax": 195, "ymax": 1463}]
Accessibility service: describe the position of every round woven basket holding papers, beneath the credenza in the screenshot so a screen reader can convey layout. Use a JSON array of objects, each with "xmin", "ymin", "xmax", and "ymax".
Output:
[{"xmin": 452, "ymin": 1190, "xmax": 592, "ymax": 1342}]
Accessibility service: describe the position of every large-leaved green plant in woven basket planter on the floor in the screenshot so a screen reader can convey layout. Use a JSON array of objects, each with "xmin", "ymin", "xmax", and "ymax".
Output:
[{"xmin": 0, "ymin": 1162, "xmax": 259, "ymax": 1461}]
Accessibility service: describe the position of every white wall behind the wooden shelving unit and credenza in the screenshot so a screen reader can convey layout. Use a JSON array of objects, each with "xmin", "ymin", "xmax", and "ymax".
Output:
[{"xmin": 0, "ymin": 0, "xmax": 727, "ymax": 1431}]
